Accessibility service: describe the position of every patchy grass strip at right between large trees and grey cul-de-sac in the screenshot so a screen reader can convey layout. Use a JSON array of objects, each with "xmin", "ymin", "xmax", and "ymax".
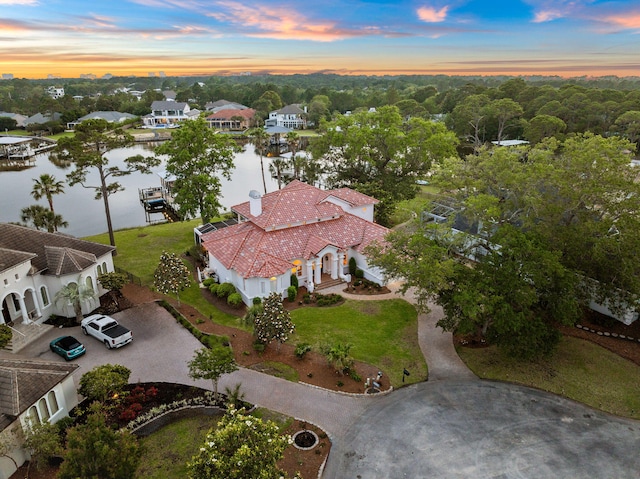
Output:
[{"xmin": 458, "ymin": 337, "xmax": 640, "ymax": 419}]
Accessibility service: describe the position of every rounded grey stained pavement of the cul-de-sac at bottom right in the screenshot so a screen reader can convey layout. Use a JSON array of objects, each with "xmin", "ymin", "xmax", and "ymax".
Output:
[{"xmin": 323, "ymin": 381, "xmax": 640, "ymax": 479}]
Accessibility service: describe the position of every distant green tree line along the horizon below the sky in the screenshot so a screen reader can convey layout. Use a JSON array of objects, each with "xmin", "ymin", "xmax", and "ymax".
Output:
[{"xmin": 0, "ymin": 74, "xmax": 640, "ymax": 146}]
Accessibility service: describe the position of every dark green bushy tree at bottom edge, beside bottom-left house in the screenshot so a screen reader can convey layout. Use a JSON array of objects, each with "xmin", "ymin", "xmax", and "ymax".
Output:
[{"xmin": 57, "ymin": 405, "xmax": 140, "ymax": 479}]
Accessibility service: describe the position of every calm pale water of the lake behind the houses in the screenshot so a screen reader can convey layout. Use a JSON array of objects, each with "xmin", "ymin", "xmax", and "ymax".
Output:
[{"xmin": 0, "ymin": 144, "xmax": 278, "ymax": 240}]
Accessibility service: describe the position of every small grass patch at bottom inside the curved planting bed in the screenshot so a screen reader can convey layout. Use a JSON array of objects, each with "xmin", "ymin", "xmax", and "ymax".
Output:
[{"xmin": 135, "ymin": 415, "xmax": 222, "ymax": 479}]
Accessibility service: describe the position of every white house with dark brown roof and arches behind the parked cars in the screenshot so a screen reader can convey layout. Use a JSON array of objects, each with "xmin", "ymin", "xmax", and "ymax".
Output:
[{"xmin": 0, "ymin": 223, "xmax": 115, "ymax": 346}]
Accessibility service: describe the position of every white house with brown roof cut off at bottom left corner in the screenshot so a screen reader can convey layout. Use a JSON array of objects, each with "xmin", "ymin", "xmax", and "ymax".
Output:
[{"xmin": 0, "ymin": 359, "xmax": 79, "ymax": 479}]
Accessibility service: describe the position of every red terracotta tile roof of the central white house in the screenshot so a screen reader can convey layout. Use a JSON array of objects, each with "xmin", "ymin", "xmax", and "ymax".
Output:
[{"xmin": 202, "ymin": 181, "xmax": 389, "ymax": 278}]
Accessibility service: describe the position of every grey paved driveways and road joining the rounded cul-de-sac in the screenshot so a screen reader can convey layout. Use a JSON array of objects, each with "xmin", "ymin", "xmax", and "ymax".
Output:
[{"xmin": 5, "ymin": 303, "xmax": 640, "ymax": 479}]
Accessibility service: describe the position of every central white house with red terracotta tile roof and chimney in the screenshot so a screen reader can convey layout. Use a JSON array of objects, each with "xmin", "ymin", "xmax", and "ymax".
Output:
[{"xmin": 196, "ymin": 180, "xmax": 389, "ymax": 305}]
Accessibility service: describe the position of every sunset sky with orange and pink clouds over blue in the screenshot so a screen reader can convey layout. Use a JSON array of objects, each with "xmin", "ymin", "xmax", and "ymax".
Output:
[{"xmin": 0, "ymin": 0, "xmax": 640, "ymax": 78}]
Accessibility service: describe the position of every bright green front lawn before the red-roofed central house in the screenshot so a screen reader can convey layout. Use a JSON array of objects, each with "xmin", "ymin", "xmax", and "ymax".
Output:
[{"xmin": 289, "ymin": 299, "xmax": 427, "ymax": 387}]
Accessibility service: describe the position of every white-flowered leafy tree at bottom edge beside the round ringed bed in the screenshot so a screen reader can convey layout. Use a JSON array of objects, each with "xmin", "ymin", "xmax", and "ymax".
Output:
[{"xmin": 188, "ymin": 410, "xmax": 291, "ymax": 479}]
